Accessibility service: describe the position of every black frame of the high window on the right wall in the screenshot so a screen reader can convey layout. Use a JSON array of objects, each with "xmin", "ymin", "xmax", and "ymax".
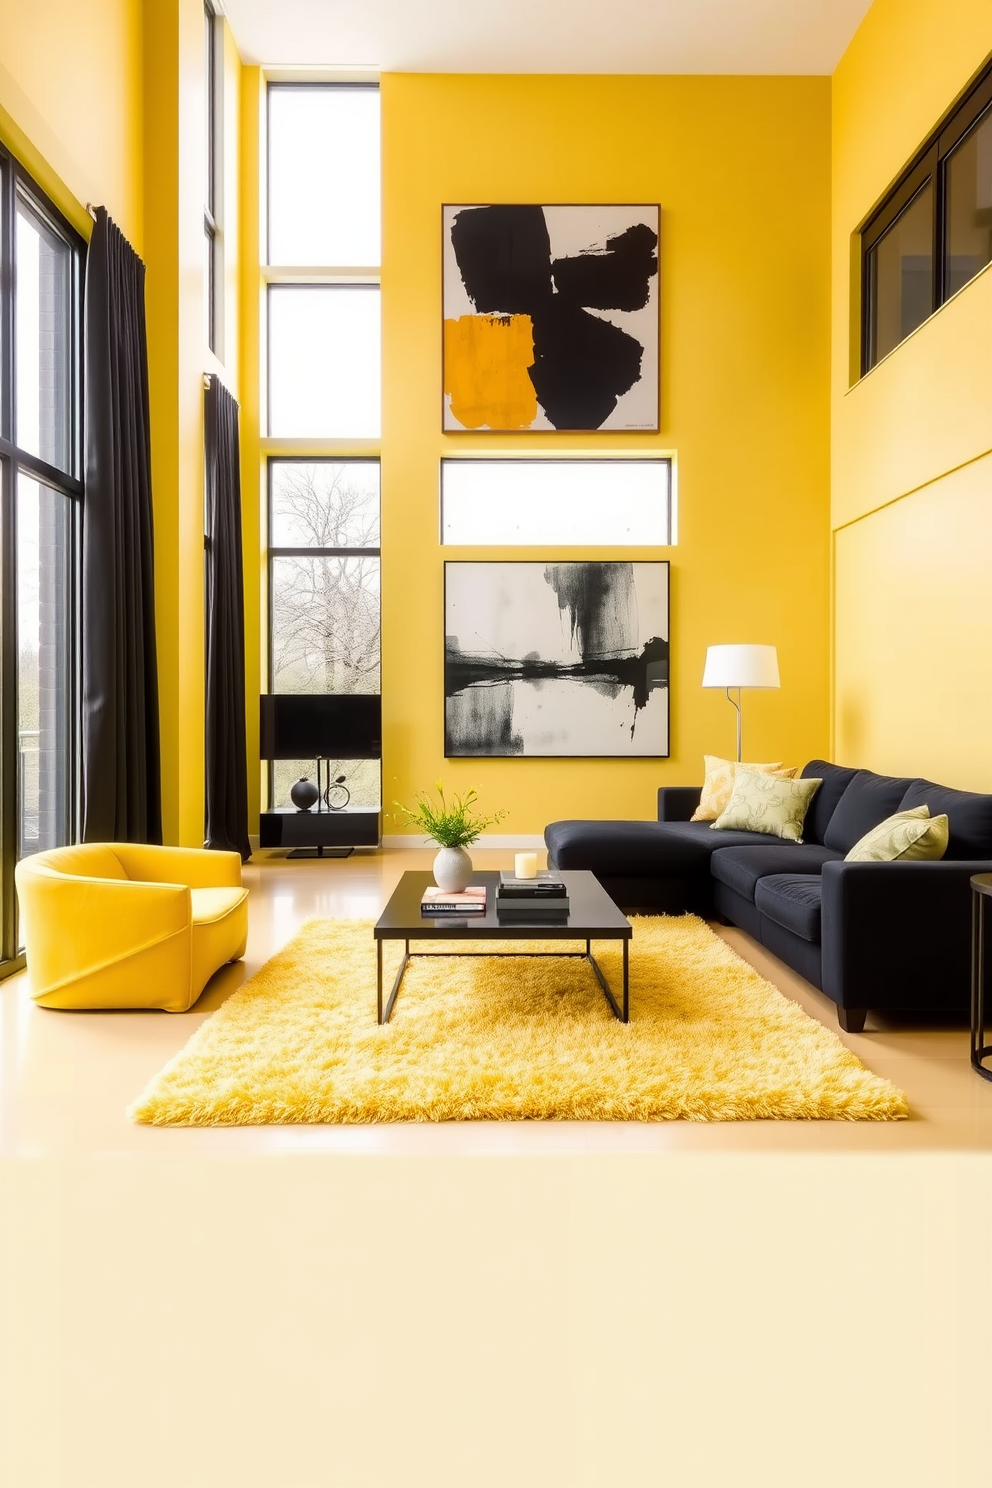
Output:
[{"xmin": 857, "ymin": 61, "xmax": 992, "ymax": 376}]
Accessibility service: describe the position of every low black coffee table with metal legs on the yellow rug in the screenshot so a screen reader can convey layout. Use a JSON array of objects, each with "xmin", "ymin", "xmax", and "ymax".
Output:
[{"xmin": 373, "ymin": 869, "xmax": 634, "ymax": 1024}]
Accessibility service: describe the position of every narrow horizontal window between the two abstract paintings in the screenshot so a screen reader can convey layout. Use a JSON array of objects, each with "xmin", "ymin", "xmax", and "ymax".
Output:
[{"xmin": 440, "ymin": 460, "xmax": 672, "ymax": 548}]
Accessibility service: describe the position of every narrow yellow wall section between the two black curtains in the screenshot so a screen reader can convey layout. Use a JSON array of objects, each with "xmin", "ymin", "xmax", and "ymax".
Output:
[{"xmin": 144, "ymin": 0, "xmax": 241, "ymax": 845}]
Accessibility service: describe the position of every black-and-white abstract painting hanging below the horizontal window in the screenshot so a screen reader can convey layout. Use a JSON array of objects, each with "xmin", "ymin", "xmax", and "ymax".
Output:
[{"xmin": 445, "ymin": 562, "xmax": 669, "ymax": 759}]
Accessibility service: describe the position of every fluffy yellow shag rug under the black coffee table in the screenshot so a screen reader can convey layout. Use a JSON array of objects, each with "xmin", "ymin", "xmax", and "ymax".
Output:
[{"xmin": 128, "ymin": 915, "xmax": 907, "ymax": 1126}]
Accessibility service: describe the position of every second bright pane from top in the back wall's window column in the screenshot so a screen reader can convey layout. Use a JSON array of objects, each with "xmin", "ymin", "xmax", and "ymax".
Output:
[{"xmin": 269, "ymin": 284, "xmax": 381, "ymax": 439}]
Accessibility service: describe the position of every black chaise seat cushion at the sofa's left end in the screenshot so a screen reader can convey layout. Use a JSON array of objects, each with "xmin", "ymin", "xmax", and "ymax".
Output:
[{"xmin": 544, "ymin": 821, "xmax": 767, "ymax": 878}]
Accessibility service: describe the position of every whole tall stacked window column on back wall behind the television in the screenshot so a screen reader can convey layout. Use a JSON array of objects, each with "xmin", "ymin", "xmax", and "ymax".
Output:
[{"xmin": 265, "ymin": 83, "xmax": 381, "ymax": 806}]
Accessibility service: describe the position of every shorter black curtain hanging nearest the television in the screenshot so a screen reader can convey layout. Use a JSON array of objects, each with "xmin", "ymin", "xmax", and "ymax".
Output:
[{"xmin": 204, "ymin": 376, "xmax": 251, "ymax": 859}]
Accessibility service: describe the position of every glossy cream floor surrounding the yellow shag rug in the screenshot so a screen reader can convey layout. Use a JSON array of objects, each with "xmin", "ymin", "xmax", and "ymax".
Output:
[{"xmin": 0, "ymin": 851, "xmax": 992, "ymax": 1156}]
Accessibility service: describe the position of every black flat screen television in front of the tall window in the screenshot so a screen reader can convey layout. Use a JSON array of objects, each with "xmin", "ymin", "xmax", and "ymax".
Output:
[{"xmin": 259, "ymin": 692, "xmax": 382, "ymax": 759}]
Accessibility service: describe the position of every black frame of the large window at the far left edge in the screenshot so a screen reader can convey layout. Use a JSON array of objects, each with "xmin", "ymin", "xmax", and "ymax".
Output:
[{"xmin": 0, "ymin": 146, "xmax": 86, "ymax": 978}]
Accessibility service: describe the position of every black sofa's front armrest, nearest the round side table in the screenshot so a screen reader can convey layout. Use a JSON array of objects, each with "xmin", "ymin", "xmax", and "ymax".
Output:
[{"xmin": 821, "ymin": 860, "xmax": 992, "ymax": 1013}]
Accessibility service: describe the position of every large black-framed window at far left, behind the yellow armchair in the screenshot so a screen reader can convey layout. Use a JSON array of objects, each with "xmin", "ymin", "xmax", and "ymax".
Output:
[{"xmin": 0, "ymin": 150, "xmax": 83, "ymax": 970}]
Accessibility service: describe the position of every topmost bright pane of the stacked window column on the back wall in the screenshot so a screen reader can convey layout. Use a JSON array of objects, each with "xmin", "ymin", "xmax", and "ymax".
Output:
[{"xmin": 269, "ymin": 83, "xmax": 381, "ymax": 266}]
